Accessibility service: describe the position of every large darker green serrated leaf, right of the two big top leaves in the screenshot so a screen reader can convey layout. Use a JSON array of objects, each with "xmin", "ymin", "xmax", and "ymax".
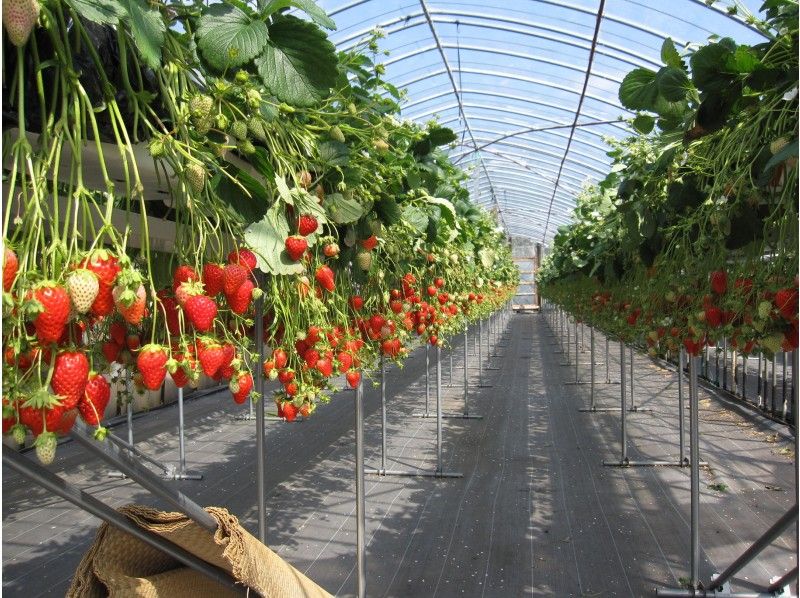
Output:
[{"xmin": 256, "ymin": 16, "xmax": 337, "ymax": 106}]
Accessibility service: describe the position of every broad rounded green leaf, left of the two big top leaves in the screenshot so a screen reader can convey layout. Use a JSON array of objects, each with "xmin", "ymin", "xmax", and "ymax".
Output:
[{"xmin": 197, "ymin": 3, "xmax": 269, "ymax": 71}]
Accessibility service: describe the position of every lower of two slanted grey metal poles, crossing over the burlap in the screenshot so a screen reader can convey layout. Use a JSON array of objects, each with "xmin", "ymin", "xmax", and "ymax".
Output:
[{"xmin": 3, "ymin": 448, "xmax": 248, "ymax": 595}]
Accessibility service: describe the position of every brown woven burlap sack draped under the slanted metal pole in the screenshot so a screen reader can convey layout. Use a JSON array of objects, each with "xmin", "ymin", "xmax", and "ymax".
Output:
[{"xmin": 67, "ymin": 505, "xmax": 330, "ymax": 598}]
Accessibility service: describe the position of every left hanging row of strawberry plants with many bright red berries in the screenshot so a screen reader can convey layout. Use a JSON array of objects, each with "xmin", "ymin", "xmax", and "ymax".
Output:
[{"xmin": 3, "ymin": 0, "xmax": 518, "ymax": 463}]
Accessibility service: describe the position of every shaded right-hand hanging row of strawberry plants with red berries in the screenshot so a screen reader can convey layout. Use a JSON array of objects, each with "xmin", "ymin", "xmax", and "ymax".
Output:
[{"xmin": 539, "ymin": 0, "xmax": 798, "ymax": 356}]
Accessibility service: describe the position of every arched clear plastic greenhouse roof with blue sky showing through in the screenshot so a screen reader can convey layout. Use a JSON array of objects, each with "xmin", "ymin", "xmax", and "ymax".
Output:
[{"xmin": 318, "ymin": 0, "xmax": 763, "ymax": 245}]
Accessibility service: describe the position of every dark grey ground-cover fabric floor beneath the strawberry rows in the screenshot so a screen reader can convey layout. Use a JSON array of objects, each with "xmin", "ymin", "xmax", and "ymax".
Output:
[{"xmin": 3, "ymin": 315, "xmax": 797, "ymax": 598}]
